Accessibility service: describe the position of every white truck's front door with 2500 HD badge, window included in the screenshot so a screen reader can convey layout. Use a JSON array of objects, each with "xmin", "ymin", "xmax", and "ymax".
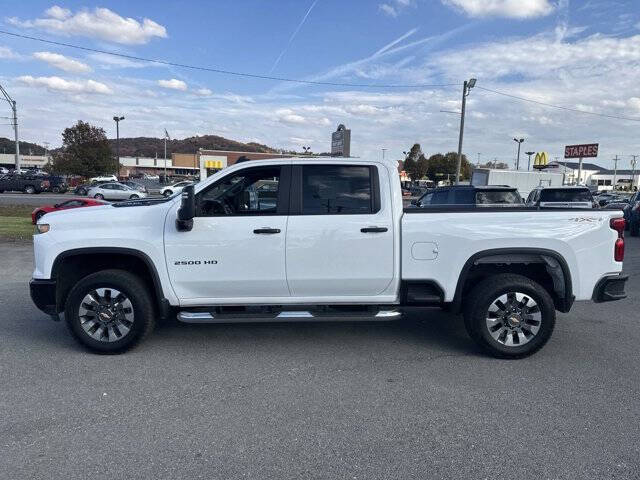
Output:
[{"xmin": 165, "ymin": 165, "xmax": 291, "ymax": 305}]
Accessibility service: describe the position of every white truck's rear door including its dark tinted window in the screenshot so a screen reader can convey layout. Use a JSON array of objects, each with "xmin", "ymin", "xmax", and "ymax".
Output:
[{"xmin": 287, "ymin": 162, "xmax": 394, "ymax": 299}]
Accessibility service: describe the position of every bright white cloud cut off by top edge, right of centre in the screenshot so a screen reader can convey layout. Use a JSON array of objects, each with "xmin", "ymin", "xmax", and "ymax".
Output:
[{"xmin": 441, "ymin": 0, "xmax": 554, "ymax": 18}]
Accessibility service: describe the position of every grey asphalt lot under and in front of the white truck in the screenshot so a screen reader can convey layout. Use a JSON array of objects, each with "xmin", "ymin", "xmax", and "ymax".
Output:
[{"xmin": 0, "ymin": 238, "xmax": 640, "ymax": 479}]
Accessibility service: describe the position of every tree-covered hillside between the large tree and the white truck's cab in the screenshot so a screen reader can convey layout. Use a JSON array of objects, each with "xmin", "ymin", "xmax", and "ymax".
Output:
[{"xmin": 109, "ymin": 135, "xmax": 277, "ymax": 157}]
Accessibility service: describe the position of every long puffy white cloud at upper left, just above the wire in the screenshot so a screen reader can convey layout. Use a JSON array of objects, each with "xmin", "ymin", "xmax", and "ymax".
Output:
[{"xmin": 7, "ymin": 5, "xmax": 167, "ymax": 45}]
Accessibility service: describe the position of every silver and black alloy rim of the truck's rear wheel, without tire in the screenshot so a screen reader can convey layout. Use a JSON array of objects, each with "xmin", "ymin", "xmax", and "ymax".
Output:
[{"xmin": 487, "ymin": 292, "xmax": 542, "ymax": 347}]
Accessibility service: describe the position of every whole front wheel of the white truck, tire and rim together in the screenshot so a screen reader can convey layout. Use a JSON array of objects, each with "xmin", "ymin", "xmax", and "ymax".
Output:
[{"xmin": 65, "ymin": 270, "xmax": 154, "ymax": 354}]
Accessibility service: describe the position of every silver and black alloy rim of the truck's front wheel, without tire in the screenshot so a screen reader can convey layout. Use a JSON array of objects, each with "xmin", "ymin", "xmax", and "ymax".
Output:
[{"xmin": 78, "ymin": 288, "xmax": 134, "ymax": 342}]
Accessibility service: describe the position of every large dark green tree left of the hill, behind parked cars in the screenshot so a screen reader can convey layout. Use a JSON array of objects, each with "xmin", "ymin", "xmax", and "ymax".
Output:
[{"xmin": 52, "ymin": 120, "xmax": 118, "ymax": 177}]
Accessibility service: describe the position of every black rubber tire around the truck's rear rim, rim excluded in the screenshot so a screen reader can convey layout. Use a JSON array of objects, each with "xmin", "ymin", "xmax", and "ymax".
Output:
[{"xmin": 464, "ymin": 274, "xmax": 556, "ymax": 359}]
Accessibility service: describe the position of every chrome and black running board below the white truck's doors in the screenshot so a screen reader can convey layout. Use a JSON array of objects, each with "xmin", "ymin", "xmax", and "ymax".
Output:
[{"xmin": 177, "ymin": 310, "xmax": 402, "ymax": 323}]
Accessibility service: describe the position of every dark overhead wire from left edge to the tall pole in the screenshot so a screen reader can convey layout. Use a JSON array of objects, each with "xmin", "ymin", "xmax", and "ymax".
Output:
[{"xmin": 0, "ymin": 30, "xmax": 458, "ymax": 88}]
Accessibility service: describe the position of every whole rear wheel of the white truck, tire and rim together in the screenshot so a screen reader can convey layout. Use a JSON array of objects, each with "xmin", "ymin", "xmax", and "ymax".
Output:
[{"xmin": 464, "ymin": 274, "xmax": 556, "ymax": 358}]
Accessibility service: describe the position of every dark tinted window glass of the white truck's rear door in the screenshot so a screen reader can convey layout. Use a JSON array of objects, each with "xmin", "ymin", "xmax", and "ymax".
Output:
[{"xmin": 302, "ymin": 165, "xmax": 374, "ymax": 215}]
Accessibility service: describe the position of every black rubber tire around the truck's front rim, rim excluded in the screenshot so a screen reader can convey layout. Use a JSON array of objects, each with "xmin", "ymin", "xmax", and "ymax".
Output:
[{"xmin": 65, "ymin": 270, "xmax": 155, "ymax": 354}]
